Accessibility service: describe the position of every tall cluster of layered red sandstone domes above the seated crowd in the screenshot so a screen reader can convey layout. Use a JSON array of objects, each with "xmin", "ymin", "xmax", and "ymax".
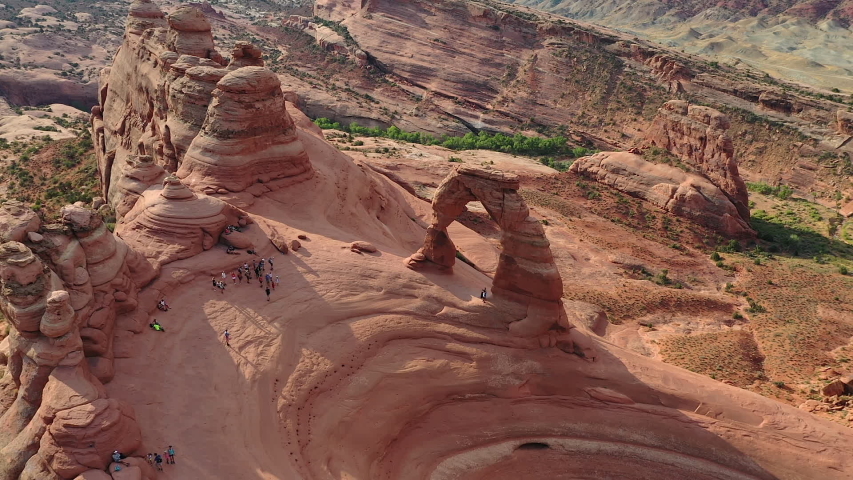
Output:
[{"xmin": 92, "ymin": 0, "xmax": 313, "ymax": 219}]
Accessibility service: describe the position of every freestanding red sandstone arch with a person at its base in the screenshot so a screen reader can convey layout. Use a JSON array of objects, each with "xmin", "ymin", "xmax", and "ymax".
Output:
[{"xmin": 407, "ymin": 166, "xmax": 572, "ymax": 346}]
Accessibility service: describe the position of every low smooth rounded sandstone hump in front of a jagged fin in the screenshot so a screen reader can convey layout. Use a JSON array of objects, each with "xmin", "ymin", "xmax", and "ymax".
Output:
[{"xmin": 570, "ymin": 152, "xmax": 755, "ymax": 238}]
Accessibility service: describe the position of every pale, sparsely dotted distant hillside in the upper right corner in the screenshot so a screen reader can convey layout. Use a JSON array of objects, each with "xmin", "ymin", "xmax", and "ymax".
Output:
[{"xmin": 511, "ymin": 0, "xmax": 853, "ymax": 94}]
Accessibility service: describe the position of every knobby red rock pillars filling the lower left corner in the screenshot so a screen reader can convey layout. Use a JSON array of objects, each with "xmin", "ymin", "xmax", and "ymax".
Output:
[{"xmin": 0, "ymin": 242, "xmax": 141, "ymax": 480}]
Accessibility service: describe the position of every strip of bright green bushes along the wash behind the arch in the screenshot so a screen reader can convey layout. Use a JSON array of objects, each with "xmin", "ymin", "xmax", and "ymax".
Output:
[{"xmin": 314, "ymin": 118, "xmax": 590, "ymax": 157}]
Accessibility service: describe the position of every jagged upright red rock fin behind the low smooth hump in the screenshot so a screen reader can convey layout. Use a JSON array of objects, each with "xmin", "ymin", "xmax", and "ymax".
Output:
[{"xmin": 647, "ymin": 100, "xmax": 749, "ymax": 222}]
